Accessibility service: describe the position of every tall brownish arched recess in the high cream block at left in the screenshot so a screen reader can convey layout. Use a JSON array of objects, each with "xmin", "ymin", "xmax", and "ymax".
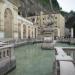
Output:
[{"xmin": 4, "ymin": 8, "xmax": 13, "ymax": 38}]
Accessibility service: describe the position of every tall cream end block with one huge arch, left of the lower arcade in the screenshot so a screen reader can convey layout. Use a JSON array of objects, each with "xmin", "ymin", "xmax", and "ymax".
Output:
[{"xmin": 0, "ymin": 0, "xmax": 18, "ymax": 38}]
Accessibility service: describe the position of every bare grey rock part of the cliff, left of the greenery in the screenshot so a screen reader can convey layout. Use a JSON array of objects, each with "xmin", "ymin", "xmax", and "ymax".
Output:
[{"xmin": 19, "ymin": 0, "xmax": 45, "ymax": 17}]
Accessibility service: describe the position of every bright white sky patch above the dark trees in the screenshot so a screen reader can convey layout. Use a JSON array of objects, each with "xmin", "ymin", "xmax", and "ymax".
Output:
[{"xmin": 57, "ymin": 0, "xmax": 75, "ymax": 12}]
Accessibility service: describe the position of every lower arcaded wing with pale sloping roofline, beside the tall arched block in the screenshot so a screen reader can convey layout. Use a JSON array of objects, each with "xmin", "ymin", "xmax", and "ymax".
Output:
[{"xmin": 17, "ymin": 16, "xmax": 38, "ymax": 39}]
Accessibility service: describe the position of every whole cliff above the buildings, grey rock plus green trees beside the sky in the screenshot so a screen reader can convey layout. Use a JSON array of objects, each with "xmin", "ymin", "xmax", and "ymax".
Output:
[{"xmin": 19, "ymin": 0, "xmax": 60, "ymax": 17}]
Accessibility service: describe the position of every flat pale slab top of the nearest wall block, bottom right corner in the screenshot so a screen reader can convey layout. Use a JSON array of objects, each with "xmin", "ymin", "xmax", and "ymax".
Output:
[{"xmin": 60, "ymin": 61, "xmax": 75, "ymax": 75}]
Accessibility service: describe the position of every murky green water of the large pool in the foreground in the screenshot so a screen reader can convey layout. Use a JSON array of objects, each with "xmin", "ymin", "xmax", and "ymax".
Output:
[{"xmin": 8, "ymin": 44, "xmax": 54, "ymax": 75}]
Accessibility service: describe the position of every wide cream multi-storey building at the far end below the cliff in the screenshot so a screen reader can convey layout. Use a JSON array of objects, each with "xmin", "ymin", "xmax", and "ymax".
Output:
[{"xmin": 27, "ymin": 12, "xmax": 65, "ymax": 37}]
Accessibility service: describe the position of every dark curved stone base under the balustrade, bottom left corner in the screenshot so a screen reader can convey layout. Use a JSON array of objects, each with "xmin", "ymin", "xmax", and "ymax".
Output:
[{"xmin": 0, "ymin": 57, "xmax": 16, "ymax": 75}]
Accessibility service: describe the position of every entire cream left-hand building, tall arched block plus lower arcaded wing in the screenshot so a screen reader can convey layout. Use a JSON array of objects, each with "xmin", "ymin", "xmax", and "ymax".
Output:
[{"xmin": 0, "ymin": 0, "xmax": 37, "ymax": 39}]
